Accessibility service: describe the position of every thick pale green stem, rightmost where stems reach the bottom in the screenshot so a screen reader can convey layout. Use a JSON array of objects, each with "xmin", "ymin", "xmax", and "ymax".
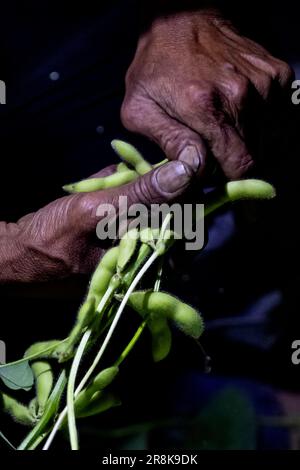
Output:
[{"xmin": 67, "ymin": 330, "xmax": 92, "ymax": 450}]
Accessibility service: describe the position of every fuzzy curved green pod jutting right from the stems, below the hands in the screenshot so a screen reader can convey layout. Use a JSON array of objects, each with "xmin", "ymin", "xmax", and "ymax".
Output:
[{"xmin": 128, "ymin": 291, "xmax": 204, "ymax": 338}]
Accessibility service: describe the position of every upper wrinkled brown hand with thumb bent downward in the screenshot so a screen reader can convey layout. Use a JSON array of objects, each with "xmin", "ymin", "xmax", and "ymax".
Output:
[{"xmin": 121, "ymin": 11, "xmax": 294, "ymax": 179}]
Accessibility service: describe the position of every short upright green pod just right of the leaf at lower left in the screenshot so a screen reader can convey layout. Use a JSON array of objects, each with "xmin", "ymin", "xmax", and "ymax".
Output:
[{"xmin": 31, "ymin": 361, "xmax": 53, "ymax": 416}]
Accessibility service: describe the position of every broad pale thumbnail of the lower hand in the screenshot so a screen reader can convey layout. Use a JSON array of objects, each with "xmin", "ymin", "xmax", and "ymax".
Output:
[{"xmin": 156, "ymin": 160, "xmax": 193, "ymax": 193}]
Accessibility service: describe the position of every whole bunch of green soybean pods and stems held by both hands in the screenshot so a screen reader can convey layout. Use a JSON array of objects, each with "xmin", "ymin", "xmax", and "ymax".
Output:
[{"xmin": 0, "ymin": 140, "xmax": 275, "ymax": 450}]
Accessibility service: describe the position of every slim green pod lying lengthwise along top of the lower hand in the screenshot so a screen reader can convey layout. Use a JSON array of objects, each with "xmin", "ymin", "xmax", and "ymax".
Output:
[{"xmin": 63, "ymin": 170, "xmax": 138, "ymax": 194}]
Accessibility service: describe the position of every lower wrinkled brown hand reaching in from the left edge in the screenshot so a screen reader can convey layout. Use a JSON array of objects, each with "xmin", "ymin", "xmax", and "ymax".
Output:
[{"xmin": 0, "ymin": 162, "xmax": 193, "ymax": 283}]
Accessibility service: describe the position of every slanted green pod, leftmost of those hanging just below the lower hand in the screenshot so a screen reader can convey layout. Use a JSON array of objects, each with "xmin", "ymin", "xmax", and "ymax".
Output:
[{"xmin": 88, "ymin": 246, "xmax": 119, "ymax": 304}]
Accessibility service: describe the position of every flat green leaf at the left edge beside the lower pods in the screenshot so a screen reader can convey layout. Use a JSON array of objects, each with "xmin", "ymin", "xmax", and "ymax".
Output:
[{"xmin": 0, "ymin": 361, "xmax": 34, "ymax": 391}]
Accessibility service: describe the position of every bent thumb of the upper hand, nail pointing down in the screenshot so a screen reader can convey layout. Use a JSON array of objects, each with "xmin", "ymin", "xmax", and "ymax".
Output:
[{"xmin": 121, "ymin": 99, "xmax": 207, "ymax": 172}]
